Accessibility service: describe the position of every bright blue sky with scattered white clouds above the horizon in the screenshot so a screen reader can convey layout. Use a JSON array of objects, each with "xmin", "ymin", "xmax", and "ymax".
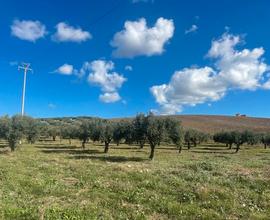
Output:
[{"xmin": 0, "ymin": 0, "xmax": 270, "ymax": 118}]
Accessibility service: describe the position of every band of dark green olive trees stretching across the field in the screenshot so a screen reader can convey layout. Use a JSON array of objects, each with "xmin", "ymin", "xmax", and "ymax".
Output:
[{"xmin": 0, "ymin": 113, "xmax": 270, "ymax": 159}]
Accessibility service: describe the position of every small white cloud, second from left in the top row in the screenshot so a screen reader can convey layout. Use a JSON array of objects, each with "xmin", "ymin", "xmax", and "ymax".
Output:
[{"xmin": 52, "ymin": 22, "xmax": 92, "ymax": 43}]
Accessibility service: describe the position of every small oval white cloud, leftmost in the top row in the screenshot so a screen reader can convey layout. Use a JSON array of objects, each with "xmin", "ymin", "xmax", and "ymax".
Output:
[{"xmin": 11, "ymin": 19, "xmax": 46, "ymax": 42}]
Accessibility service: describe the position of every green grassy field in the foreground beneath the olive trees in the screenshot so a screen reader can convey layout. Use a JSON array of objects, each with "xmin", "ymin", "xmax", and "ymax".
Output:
[{"xmin": 0, "ymin": 142, "xmax": 270, "ymax": 220}]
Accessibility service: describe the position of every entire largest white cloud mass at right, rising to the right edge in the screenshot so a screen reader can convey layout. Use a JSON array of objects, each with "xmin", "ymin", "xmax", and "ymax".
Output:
[{"xmin": 150, "ymin": 34, "xmax": 270, "ymax": 114}]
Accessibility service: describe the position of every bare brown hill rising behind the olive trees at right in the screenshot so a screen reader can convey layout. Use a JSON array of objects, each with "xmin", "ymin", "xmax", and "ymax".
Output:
[{"xmin": 171, "ymin": 115, "xmax": 270, "ymax": 133}]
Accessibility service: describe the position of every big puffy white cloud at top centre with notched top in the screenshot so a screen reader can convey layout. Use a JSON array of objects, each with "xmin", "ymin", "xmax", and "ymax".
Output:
[{"xmin": 111, "ymin": 18, "xmax": 174, "ymax": 58}]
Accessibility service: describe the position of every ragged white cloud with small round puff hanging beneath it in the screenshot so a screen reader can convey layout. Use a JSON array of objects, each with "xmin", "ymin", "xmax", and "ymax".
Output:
[{"xmin": 87, "ymin": 60, "xmax": 127, "ymax": 103}]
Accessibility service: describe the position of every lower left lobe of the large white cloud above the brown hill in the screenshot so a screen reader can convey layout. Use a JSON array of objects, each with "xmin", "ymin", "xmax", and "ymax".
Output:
[{"xmin": 151, "ymin": 67, "xmax": 226, "ymax": 114}]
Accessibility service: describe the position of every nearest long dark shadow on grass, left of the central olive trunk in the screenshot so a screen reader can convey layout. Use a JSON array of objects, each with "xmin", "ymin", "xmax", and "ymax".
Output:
[{"xmin": 71, "ymin": 155, "xmax": 147, "ymax": 163}]
